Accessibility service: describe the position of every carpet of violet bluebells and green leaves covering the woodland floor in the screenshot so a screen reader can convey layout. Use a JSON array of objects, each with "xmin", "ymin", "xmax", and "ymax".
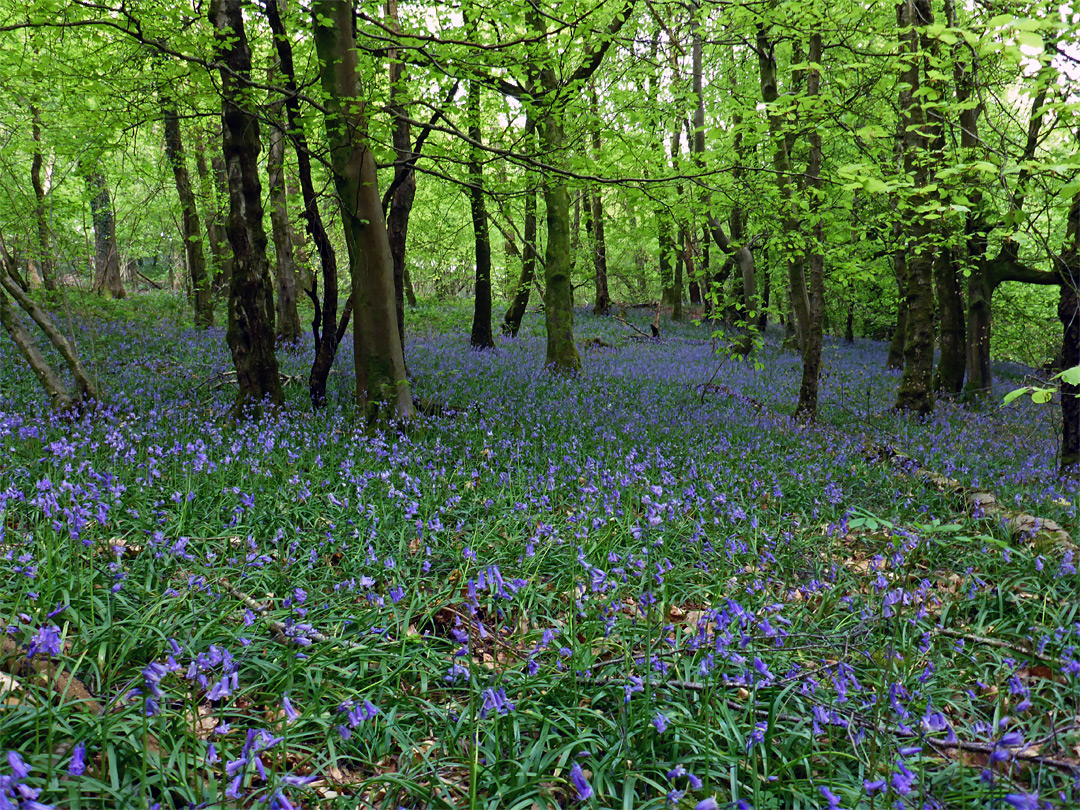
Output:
[{"xmin": 0, "ymin": 306, "xmax": 1080, "ymax": 810}]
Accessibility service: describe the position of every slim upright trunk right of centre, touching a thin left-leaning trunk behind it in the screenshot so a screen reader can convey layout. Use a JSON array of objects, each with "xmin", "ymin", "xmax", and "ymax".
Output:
[{"xmin": 795, "ymin": 31, "xmax": 825, "ymax": 420}]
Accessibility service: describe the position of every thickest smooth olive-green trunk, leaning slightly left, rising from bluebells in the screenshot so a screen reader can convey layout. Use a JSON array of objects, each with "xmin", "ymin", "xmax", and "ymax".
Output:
[{"xmin": 312, "ymin": 0, "xmax": 414, "ymax": 419}]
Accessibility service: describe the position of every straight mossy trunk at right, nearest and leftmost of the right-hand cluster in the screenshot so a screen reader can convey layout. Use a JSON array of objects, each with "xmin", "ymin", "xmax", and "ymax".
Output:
[{"xmin": 896, "ymin": 0, "xmax": 935, "ymax": 415}]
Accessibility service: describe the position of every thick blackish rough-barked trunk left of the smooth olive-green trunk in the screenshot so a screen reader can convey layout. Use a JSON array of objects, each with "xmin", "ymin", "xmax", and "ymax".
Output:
[{"xmin": 210, "ymin": 0, "xmax": 284, "ymax": 418}]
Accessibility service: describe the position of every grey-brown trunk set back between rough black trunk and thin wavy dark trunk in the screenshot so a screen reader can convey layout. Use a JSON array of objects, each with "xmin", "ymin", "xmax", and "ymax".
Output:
[{"xmin": 267, "ymin": 45, "xmax": 300, "ymax": 343}]
